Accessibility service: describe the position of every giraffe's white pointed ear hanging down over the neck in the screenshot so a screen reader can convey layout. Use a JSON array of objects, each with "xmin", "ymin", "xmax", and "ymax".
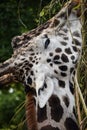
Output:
[{"xmin": 38, "ymin": 77, "xmax": 54, "ymax": 108}]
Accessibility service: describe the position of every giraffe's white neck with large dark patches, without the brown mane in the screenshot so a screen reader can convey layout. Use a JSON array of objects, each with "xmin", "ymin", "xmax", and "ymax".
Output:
[{"xmin": 37, "ymin": 76, "xmax": 79, "ymax": 130}]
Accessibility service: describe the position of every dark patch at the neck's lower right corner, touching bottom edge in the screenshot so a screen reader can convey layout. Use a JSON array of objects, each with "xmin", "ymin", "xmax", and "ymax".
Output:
[{"xmin": 64, "ymin": 117, "xmax": 79, "ymax": 130}]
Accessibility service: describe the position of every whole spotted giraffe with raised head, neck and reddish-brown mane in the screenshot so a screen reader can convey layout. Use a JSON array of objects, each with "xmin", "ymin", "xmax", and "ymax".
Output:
[{"xmin": 0, "ymin": 0, "xmax": 82, "ymax": 130}]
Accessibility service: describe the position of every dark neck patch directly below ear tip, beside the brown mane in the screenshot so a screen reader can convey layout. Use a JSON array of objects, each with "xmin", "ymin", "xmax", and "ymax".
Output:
[{"xmin": 37, "ymin": 105, "xmax": 47, "ymax": 123}]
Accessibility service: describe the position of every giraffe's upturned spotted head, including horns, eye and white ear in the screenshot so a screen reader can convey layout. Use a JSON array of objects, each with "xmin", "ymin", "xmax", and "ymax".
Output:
[{"xmin": 0, "ymin": 0, "xmax": 81, "ymax": 108}]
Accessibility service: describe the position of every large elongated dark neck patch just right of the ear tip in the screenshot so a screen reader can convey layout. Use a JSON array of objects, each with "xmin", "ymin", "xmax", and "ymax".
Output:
[{"xmin": 49, "ymin": 95, "xmax": 63, "ymax": 122}]
